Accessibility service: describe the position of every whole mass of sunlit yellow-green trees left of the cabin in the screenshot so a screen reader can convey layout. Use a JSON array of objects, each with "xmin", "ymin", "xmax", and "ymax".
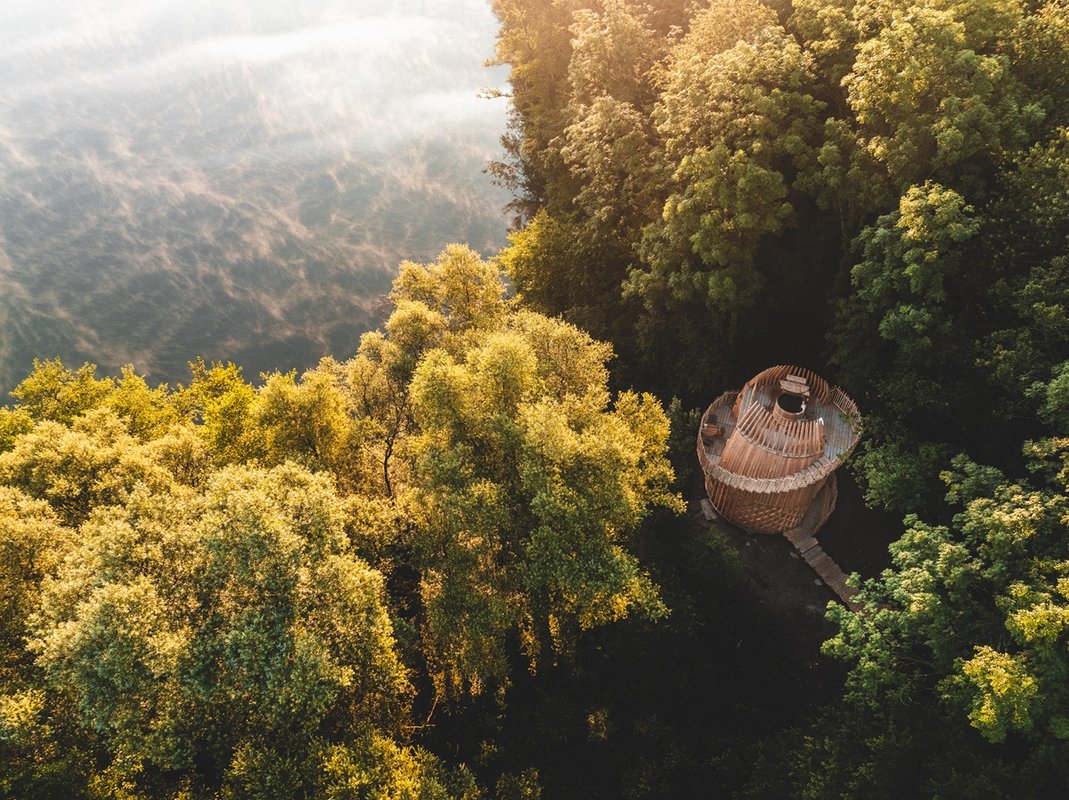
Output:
[{"xmin": 0, "ymin": 246, "xmax": 680, "ymax": 799}]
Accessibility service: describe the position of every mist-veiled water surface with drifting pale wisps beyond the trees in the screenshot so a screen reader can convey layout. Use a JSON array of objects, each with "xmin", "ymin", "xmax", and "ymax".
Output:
[{"xmin": 0, "ymin": 0, "xmax": 508, "ymax": 399}]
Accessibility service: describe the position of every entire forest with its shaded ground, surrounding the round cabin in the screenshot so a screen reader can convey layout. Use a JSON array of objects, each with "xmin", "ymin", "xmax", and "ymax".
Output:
[{"xmin": 0, "ymin": 0, "xmax": 1069, "ymax": 800}]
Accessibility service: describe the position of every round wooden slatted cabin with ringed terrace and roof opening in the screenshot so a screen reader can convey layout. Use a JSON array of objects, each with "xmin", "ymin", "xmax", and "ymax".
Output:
[{"xmin": 698, "ymin": 366, "xmax": 861, "ymax": 535}]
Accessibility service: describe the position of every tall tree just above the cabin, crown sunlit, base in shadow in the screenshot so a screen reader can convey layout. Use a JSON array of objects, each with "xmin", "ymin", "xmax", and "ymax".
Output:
[{"xmin": 625, "ymin": 8, "xmax": 823, "ymax": 385}]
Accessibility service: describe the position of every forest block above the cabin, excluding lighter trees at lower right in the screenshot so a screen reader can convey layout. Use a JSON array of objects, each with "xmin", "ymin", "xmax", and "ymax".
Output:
[{"xmin": 495, "ymin": 0, "xmax": 1069, "ymax": 513}]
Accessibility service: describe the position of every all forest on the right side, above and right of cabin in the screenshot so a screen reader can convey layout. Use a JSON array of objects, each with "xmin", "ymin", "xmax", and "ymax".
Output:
[{"xmin": 494, "ymin": 0, "xmax": 1069, "ymax": 797}]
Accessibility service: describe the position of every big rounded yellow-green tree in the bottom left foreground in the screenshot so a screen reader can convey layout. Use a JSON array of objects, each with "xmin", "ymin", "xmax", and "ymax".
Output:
[{"xmin": 31, "ymin": 464, "xmax": 455, "ymax": 797}]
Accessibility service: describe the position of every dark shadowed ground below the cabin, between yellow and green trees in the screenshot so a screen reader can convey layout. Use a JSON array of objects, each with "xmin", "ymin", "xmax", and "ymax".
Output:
[{"xmin": 420, "ymin": 475, "xmax": 893, "ymax": 800}]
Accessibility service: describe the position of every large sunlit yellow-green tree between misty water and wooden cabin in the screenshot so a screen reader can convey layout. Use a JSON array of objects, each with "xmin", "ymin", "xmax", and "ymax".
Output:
[{"xmin": 350, "ymin": 247, "xmax": 678, "ymax": 695}]
